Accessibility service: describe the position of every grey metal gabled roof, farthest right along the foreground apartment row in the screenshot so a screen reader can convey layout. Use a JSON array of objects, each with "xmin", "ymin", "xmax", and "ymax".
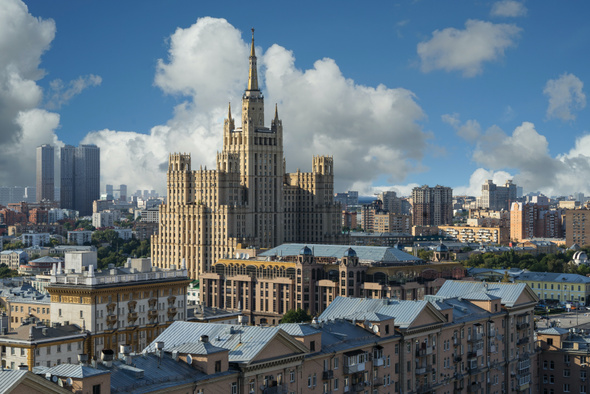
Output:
[{"xmin": 436, "ymin": 280, "xmax": 527, "ymax": 307}]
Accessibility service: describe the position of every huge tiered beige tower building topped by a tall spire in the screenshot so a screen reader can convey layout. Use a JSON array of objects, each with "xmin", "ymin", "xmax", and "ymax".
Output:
[{"xmin": 152, "ymin": 30, "xmax": 341, "ymax": 278}]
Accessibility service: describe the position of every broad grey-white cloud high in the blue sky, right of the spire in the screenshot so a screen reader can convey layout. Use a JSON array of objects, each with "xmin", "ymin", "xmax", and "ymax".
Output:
[{"xmin": 418, "ymin": 20, "xmax": 521, "ymax": 77}]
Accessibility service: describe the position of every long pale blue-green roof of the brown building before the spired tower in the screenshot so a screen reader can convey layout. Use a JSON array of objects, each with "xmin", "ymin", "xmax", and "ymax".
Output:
[{"xmin": 260, "ymin": 244, "xmax": 422, "ymax": 263}]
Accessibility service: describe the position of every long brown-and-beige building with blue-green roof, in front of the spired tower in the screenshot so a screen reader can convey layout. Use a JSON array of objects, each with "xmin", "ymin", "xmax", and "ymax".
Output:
[{"xmin": 200, "ymin": 244, "xmax": 465, "ymax": 324}]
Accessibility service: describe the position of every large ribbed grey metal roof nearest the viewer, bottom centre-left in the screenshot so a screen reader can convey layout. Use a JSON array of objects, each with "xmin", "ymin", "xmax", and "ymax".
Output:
[{"xmin": 144, "ymin": 321, "xmax": 300, "ymax": 363}]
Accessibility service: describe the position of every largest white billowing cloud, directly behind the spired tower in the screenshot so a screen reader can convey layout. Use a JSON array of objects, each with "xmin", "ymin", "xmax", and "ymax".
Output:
[{"xmin": 83, "ymin": 18, "xmax": 429, "ymax": 190}]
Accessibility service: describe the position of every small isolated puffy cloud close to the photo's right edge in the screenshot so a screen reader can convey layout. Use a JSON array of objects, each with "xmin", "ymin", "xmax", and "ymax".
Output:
[{"xmin": 543, "ymin": 73, "xmax": 586, "ymax": 122}]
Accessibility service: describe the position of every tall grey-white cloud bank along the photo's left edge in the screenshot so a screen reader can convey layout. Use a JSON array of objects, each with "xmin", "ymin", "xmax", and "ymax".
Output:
[{"xmin": 0, "ymin": 0, "xmax": 59, "ymax": 186}]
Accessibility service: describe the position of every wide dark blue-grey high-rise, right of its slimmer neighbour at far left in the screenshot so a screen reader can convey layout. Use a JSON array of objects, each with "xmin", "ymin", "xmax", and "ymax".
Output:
[{"xmin": 60, "ymin": 145, "xmax": 100, "ymax": 216}]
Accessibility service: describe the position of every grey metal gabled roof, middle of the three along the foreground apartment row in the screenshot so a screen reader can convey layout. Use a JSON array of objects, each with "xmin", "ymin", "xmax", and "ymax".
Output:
[{"xmin": 318, "ymin": 296, "xmax": 438, "ymax": 328}]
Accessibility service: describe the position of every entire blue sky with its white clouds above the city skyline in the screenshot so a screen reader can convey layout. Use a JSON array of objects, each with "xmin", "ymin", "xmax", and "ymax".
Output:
[{"xmin": 0, "ymin": 0, "xmax": 590, "ymax": 195}]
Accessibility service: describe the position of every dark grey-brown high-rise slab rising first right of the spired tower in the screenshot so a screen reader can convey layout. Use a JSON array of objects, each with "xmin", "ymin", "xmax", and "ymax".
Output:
[{"xmin": 412, "ymin": 185, "xmax": 453, "ymax": 226}]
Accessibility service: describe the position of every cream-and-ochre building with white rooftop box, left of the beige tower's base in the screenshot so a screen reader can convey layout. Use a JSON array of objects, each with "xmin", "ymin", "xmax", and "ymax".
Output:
[{"xmin": 45, "ymin": 252, "xmax": 190, "ymax": 357}]
